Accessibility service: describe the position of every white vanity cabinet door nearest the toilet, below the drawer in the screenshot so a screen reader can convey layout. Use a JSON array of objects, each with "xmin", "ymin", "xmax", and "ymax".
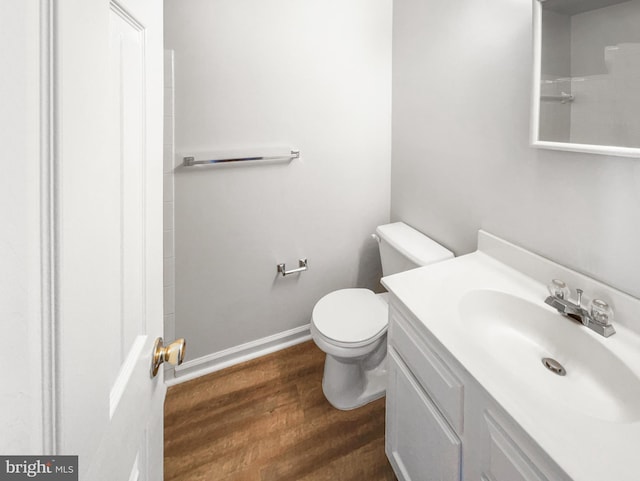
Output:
[{"xmin": 386, "ymin": 349, "xmax": 461, "ymax": 481}]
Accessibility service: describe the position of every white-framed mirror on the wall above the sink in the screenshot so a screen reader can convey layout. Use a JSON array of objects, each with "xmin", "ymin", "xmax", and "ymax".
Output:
[{"xmin": 531, "ymin": 0, "xmax": 640, "ymax": 157}]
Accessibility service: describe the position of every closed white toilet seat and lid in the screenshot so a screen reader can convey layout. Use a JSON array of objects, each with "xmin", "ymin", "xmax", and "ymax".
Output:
[{"xmin": 311, "ymin": 289, "xmax": 389, "ymax": 348}]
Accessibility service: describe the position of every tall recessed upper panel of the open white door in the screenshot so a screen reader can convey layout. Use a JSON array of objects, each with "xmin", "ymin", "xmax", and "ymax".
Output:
[{"xmin": 108, "ymin": 0, "xmax": 146, "ymax": 404}]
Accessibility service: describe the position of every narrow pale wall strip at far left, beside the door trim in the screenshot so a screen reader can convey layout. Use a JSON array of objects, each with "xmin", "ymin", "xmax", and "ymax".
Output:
[{"xmin": 0, "ymin": 1, "xmax": 46, "ymax": 455}]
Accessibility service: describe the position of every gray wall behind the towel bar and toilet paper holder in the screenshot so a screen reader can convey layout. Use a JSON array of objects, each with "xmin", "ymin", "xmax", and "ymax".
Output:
[{"xmin": 165, "ymin": 0, "xmax": 392, "ymax": 359}]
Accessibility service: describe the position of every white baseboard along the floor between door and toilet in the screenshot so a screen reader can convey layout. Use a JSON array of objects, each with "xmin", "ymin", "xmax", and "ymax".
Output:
[{"xmin": 165, "ymin": 324, "xmax": 311, "ymax": 386}]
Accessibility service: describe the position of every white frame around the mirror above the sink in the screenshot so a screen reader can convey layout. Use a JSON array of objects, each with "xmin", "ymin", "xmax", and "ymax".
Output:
[{"xmin": 531, "ymin": 0, "xmax": 640, "ymax": 158}]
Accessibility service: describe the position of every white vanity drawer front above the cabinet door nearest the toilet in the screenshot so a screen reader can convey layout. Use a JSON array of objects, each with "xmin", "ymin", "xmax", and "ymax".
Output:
[{"xmin": 389, "ymin": 308, "xmax": 464, "ymax": 434}]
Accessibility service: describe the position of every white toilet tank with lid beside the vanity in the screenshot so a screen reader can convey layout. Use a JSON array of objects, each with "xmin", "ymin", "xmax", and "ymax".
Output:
[{"xmin": 376, "ymin": 222, "xmax": 453, "ymax": 276}]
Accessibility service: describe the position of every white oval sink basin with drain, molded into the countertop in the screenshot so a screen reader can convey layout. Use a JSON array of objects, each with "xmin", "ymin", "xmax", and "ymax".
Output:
[{"xmin": 459, "ymin": 289, "xmax": 640, "ymax": 423}]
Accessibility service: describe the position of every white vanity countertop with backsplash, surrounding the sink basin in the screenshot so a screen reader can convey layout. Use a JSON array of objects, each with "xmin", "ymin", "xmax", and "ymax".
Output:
[{"xmin": 382, "ymin": 232, "xmax": 640, "ymax": 481}]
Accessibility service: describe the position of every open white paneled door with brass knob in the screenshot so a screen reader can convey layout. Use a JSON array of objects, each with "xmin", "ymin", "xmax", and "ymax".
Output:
[{"xmin": 53, "ymin": 0, "xmax": 165, "ymax": 481}]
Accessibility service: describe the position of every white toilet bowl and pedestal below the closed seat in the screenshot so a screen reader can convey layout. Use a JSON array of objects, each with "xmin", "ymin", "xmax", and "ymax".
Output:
[{"xmin": 322, "ymin": 343, "xmax": 387, "ymax": 411}]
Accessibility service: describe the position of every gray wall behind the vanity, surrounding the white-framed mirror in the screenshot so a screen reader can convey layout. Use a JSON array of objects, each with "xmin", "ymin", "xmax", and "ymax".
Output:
[{"xmin": 391, "ymin": 0, "xmax": 640, "ymax": 296}]
